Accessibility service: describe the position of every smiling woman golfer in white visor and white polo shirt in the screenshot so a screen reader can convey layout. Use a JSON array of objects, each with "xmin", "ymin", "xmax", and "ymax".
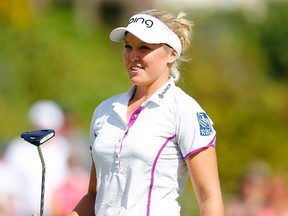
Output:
[{"xmin": 70, "ymin": 10, "xmax": 224, "ymax": 216}]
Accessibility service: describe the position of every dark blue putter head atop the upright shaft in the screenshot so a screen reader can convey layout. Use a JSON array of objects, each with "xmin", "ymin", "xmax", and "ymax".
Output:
[{"xmin": 21, "ymin": 129, "xmax": 55, "ymax": 146}]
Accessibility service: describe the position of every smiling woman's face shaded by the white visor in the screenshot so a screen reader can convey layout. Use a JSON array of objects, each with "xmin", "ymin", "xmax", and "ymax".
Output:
[{"xmin": 123, "ymin": 33, "xmax": 177, "ymax": 87}]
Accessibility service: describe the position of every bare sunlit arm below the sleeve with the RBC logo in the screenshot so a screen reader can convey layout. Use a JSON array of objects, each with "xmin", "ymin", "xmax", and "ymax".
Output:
[{"xmin": 186, "ymin": 147, "xmax": 224, "ymax": 216}]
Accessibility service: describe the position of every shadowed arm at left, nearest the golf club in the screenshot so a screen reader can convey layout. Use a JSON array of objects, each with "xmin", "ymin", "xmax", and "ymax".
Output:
[{"xmin": 69, "ymin": 162, "xmax": 97, "ymax": 216}]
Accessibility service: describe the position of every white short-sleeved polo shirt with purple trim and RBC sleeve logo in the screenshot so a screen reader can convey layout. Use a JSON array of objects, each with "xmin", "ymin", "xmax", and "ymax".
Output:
[{"xmin": 90, "ymin": 78, "xmax": 216, "ymax": 216}]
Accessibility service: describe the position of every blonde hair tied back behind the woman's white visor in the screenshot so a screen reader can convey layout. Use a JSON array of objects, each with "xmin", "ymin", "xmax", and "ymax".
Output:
[{"xmin": 141, "ymin": 9, "xmax": 193, "ymax": 81}]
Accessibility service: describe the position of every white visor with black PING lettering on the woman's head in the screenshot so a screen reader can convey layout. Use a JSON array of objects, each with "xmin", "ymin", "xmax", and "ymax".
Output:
[{"xmin": 110, "ymin": 14, "xmax": 181, "ymax": 57}]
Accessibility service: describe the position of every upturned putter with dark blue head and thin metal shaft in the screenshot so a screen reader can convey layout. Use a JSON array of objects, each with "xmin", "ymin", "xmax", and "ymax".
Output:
[{"xmin": 21, "ymin": 129, "xmax": 55, "ymax": 216}]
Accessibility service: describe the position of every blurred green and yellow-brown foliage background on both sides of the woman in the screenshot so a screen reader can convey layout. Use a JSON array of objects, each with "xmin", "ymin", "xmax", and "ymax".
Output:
[{"xmin": 0, "ymin": 0, "xmax": 288, "ymax": 215}]
